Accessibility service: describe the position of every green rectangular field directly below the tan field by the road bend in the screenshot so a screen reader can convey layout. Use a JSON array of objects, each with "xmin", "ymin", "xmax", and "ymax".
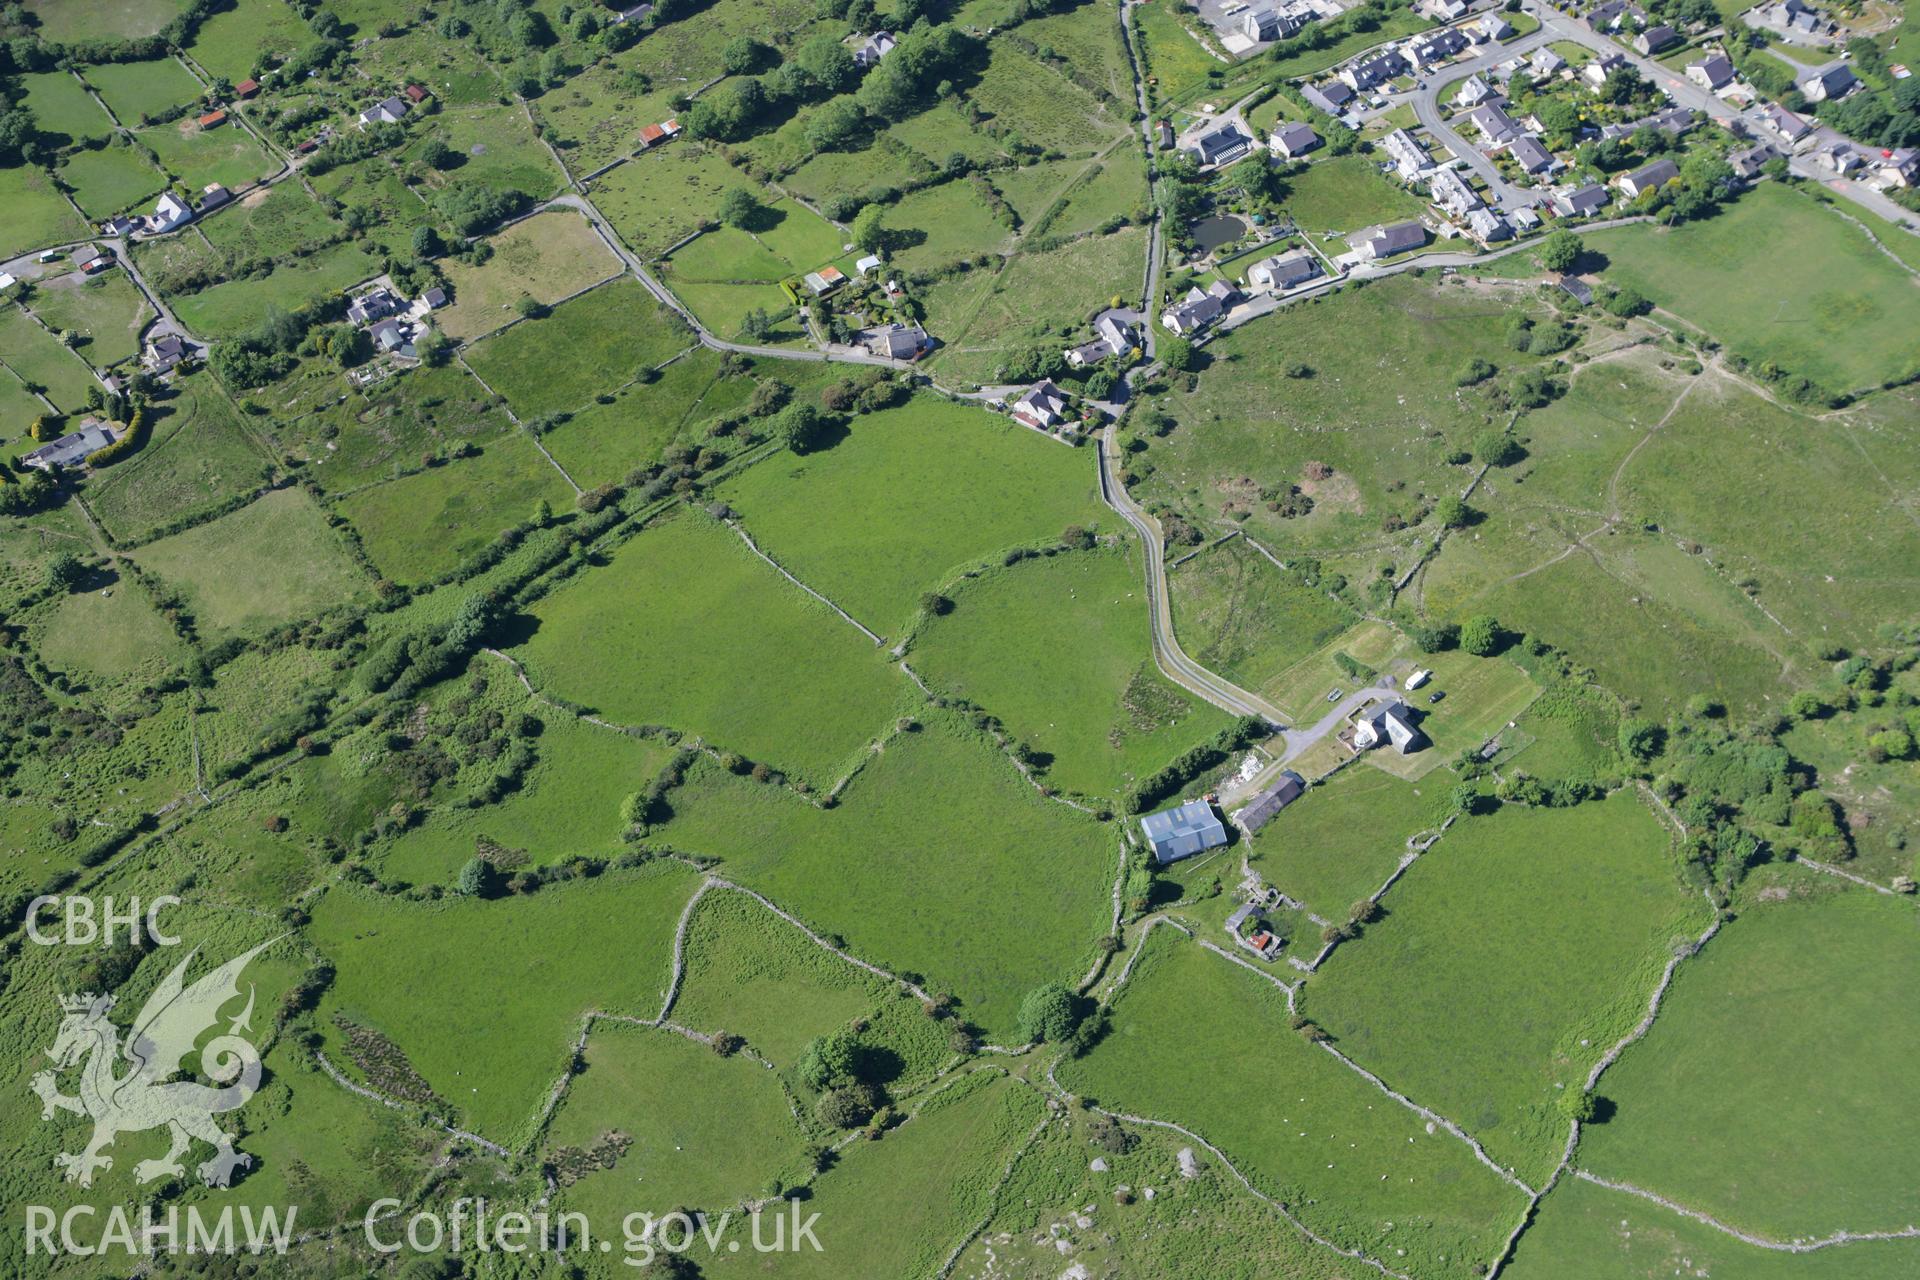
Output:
[{"xmin": 467, "ymin": 280, "xmax": 691, "ymax": 418}]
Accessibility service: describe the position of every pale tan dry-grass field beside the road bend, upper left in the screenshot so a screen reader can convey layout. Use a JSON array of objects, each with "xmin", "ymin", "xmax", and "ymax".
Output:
[{"xmin": 434, "ymin": 209, "xmax": 620, "ymax": 338}]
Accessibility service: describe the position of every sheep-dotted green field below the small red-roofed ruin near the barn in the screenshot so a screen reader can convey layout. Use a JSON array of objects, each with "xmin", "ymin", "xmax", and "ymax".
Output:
[{"xmin": 1058, "ymin": 929, "xmax": 1523, "ymax": 1278}]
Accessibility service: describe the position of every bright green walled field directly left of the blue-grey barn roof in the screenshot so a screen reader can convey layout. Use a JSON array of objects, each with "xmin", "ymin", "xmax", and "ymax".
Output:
[{"xmin": 659, "ymin": 717, "xmax": 1116, "ymax": 1044}]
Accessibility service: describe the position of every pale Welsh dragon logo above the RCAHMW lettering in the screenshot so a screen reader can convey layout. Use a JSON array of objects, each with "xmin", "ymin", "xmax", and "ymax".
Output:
[{"xmin": 33, "ymin": 938, "xmax": 278, "ymax": 1186}]
